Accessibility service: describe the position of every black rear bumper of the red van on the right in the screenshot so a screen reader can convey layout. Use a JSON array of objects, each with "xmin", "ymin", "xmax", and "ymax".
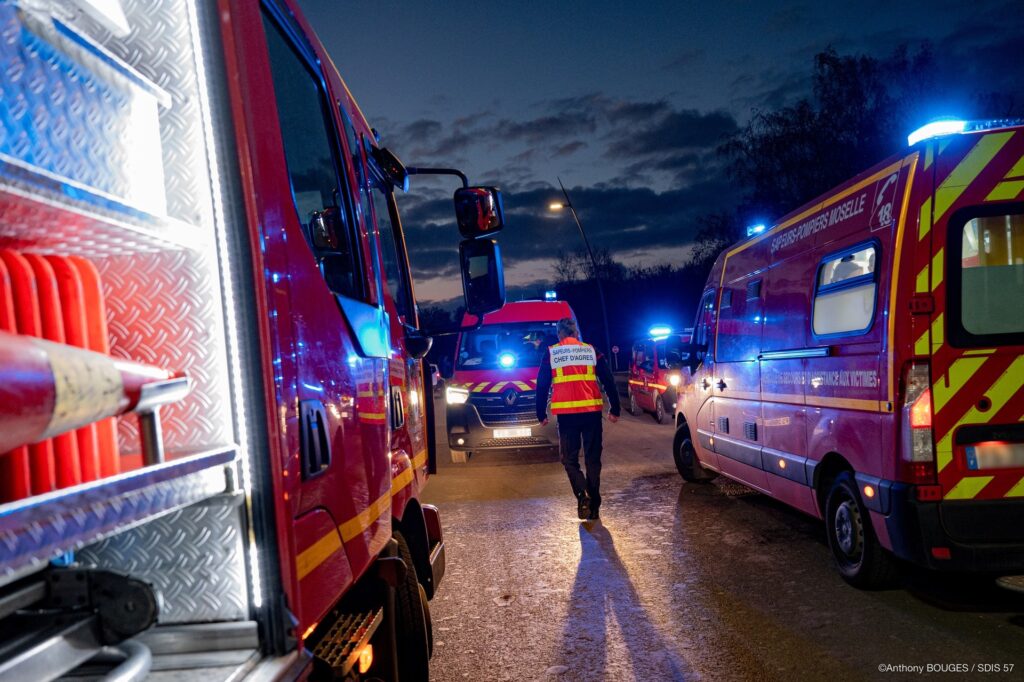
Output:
[{"xmin": 869, "ymin": 481, "xmax": 1024, "ymax": 573}]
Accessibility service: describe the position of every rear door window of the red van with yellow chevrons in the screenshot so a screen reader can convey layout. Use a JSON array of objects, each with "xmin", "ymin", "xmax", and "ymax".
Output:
[{"xmin": 959, "ymin": 214, "xmax": 1024, "ymax": 336}]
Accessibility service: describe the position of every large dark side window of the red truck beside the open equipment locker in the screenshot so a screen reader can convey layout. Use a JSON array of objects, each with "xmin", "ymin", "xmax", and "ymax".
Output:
[{"xmin": 263, "ymin": 14, "xmax": 362, "ymax": 298}]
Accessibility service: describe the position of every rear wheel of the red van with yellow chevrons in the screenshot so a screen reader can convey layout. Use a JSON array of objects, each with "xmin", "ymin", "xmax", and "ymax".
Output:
[{"xmin": 825, "ymin": 471, "xmax": 896, "ymax": 589}]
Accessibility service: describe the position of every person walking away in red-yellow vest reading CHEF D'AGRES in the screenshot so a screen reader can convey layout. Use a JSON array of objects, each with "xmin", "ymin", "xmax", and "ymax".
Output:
[{"xmin": 537, "ymin": 317, "xmax": 620, "ymax": 519}]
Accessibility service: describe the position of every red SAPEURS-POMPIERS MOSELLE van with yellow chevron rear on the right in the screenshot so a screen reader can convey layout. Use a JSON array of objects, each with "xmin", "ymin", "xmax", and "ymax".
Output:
[{"xmin": 674, "ymin": 123, "xmax": 1024, "ymax": 586}]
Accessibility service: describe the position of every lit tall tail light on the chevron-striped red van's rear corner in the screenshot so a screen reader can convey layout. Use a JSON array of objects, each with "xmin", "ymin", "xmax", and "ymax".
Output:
[{"xmin": 900, "ymin": 363, "xmax": 935, "ymax": 483}]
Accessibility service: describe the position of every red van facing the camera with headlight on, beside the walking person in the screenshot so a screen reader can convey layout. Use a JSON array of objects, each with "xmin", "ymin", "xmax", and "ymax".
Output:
[{"xmin": 444, "ymin": 300, "xmax": 575, "ymax": 462}]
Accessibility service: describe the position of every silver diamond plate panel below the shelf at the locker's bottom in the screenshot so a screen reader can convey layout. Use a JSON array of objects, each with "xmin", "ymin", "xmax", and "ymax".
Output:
[{"xmin": 78, "ymin": 498, "xmax": 248, "ymax": 624}]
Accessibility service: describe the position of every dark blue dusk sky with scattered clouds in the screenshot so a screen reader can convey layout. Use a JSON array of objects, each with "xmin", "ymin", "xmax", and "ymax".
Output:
[{"xmin": 299, "ymin": 0, "xmax": 1024, "ymax": 303}]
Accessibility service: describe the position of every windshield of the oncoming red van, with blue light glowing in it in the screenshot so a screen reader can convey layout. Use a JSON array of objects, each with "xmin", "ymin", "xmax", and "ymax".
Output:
[{"xmin": 456, "ymin": 322, "xmax": 558, "ymax": 370}]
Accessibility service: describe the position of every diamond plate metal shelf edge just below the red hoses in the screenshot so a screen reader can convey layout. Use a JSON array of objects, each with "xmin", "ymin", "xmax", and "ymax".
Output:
[{"xmin": 0, "ymin": 449, "xmax": 234, "ymax": 585}]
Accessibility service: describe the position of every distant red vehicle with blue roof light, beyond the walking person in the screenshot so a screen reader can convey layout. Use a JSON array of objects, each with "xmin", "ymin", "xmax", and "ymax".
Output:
[{"xmin": 627, "ymin": 327, "xmax": 691, "ymax": 424}]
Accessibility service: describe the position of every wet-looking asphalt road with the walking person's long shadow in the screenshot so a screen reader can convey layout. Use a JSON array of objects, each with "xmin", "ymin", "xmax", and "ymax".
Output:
[{"xmin": 425, "ymin": 393, "xmax": 1024, "ymax": 681}]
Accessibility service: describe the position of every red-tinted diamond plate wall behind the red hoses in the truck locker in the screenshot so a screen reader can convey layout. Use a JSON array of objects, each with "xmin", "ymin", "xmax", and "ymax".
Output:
[{"xmin": 96, "ymin": 251, "xmax": 233, "ymax": 453}]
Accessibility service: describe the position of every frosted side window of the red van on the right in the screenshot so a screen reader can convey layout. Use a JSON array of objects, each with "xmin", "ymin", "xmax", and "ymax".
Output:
[{"xmin": 811, "ymin": 244, "xmax": 879, "ymax": 336}]
